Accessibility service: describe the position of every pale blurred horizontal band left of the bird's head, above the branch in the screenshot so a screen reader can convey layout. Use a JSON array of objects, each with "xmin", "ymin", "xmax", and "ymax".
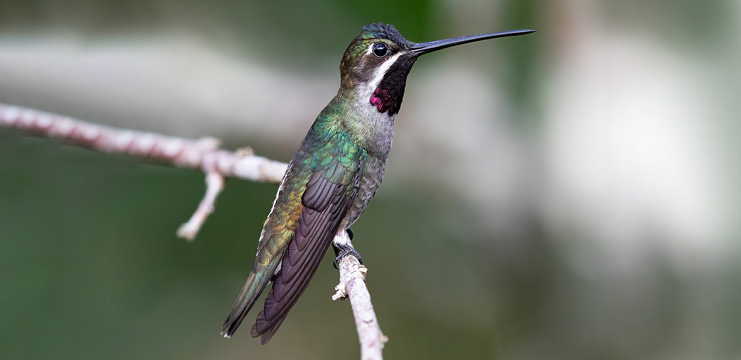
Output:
[{"xmin": 0, "ymin": 35, "xmax": 340, "ymax": 145}]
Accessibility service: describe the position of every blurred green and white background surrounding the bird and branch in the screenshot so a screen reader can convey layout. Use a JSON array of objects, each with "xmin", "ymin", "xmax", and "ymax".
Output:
[{"xmin": 0, "ymin": 0, "xmax": 741, "ymax": 360}]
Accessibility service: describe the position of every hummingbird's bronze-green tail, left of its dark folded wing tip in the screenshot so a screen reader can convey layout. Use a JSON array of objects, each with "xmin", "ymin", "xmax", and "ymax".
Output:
[{"xmin": 221, "ymin": 256, "xmax": 281, "ymax": 338}]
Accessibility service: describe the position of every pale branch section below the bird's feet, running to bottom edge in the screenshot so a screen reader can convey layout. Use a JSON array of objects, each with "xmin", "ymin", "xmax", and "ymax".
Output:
[{"xmin": 332, "ymin": 231, "xmax": 388, "ymax": 360}]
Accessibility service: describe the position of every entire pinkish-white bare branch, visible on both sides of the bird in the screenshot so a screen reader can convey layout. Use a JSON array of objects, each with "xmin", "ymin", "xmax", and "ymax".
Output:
[{"xmin": 0, "ymin": 104, "xmax": 387, "ymax": 360}]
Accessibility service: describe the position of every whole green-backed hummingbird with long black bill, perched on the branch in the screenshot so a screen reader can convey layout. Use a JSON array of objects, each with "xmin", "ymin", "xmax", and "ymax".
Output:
[{"xmin": 222, "ymin": 23, "xmax": 535, "ymax": 344}]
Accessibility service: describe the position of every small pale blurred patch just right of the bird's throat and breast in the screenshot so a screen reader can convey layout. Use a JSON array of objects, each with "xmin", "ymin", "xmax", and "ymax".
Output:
[{"xmin": 388, "ymin": 65, "xmax": 528, "ymax": 229}]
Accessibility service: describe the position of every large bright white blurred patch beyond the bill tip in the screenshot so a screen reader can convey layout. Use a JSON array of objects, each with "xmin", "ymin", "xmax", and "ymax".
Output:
[{"xmin": 544, "ymin": 29, "xmax": 728, "ymax": 269}]
